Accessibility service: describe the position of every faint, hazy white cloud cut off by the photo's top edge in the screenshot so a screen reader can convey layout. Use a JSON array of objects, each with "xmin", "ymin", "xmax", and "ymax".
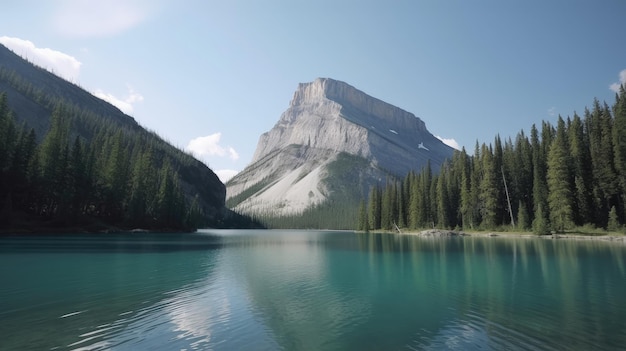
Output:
[{"xmin": 52, "ymin": 0, "xmax": 151, "ymax": 37}]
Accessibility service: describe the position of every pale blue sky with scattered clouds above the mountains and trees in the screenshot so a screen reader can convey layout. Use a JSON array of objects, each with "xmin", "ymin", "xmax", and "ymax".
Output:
[{"xmin": 0, "ymin": 0, "xmax": 626, "ymax": 180}]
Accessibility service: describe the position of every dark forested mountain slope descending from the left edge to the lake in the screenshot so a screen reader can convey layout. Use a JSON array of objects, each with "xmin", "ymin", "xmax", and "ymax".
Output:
[{"xmin": 0, "ymin": 45, "xmax": 254, "ymax": 229}]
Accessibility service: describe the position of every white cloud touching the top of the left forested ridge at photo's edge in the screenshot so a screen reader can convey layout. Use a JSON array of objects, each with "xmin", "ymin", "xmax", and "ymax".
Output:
[{"xmin": 0, "ymin": 36, "xmax": 81, "ymax": 82}]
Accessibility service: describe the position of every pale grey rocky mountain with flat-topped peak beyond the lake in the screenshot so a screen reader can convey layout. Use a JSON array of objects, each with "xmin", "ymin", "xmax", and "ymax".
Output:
[{"xmin": 226, "ymin": 78, "xmax": 453, "ymax": 217}]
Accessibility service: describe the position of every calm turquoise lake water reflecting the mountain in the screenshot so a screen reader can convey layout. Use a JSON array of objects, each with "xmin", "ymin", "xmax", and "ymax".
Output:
[{"xmin": 0, "ymin": 230, "xmax": 626, "ymax": 350}]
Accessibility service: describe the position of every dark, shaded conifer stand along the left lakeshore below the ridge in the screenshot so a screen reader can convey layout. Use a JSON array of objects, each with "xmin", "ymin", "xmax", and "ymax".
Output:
[{"xmin": 0, "ymin": 93, "xmax": 206, "ymax": 229}]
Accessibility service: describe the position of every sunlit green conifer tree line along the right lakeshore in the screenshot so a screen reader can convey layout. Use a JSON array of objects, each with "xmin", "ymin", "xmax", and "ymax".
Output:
[{"xmin": 357, "ymin": 86, "xmax": 626, "ymax": 234}]
